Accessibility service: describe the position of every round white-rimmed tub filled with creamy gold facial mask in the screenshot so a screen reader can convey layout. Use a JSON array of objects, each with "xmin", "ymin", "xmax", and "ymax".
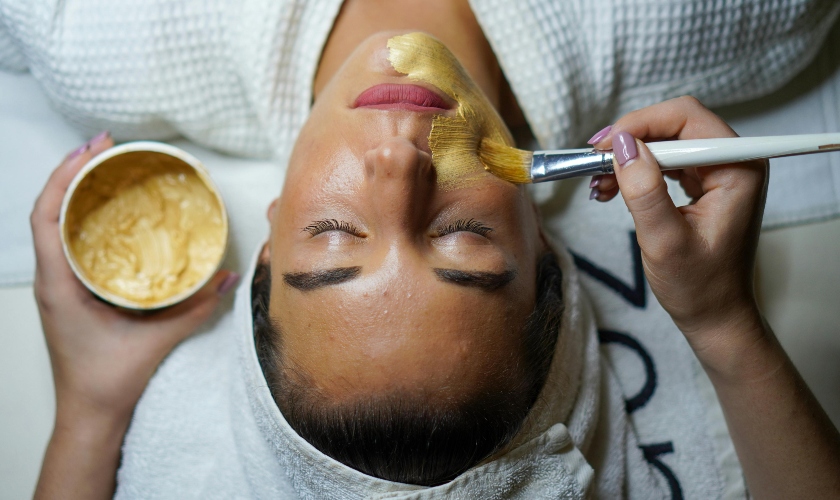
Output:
[{"xmin": 62, "ymin": 145, "xmax": 227, "ymax": 309}]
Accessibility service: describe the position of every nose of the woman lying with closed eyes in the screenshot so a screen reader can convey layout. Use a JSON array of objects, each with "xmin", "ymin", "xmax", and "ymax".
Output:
[{"xmin": 365, "ymin": 137, "xmax": 435, "ymax": 232}]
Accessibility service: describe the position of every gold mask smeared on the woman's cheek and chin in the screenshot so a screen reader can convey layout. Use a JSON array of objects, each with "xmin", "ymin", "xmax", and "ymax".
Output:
[{"xmin": 388, "ymin": 33, "xmax": 514, "ymax": 189}]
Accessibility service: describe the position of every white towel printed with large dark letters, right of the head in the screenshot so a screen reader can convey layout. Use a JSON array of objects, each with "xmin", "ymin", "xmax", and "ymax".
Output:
[{"xmin": 541, "ymin": 180, "xmax": 746, "ymax": 498}]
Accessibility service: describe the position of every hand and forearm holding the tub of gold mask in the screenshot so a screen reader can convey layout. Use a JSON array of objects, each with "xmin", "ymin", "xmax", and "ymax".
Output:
[{"xmin": 31, "ymin": 136, "xmax": 238, "ymax": 499}]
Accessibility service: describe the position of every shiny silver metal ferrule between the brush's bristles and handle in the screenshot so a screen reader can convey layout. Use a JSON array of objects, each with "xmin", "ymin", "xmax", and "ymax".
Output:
[{"xmin": 531, "ymin": 149, "xmax": 613, "ymax": 183}]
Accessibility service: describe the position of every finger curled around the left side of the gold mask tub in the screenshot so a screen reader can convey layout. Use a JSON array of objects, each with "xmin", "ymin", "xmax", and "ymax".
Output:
[{"xmin": 30, "ymin": 132, "xmax": 113, "ymax": 284}]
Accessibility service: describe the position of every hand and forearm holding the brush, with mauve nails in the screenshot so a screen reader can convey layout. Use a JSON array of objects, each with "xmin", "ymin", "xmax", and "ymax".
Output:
[{"xmin": 594, "ymin": 98, "xmax": 840, "ymax": 498}]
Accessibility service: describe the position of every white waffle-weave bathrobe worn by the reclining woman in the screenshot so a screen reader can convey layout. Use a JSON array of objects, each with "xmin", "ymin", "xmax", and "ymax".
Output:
[{"xmin": 0, "ymin": 0, "xmax": 840, "ymax": 162}]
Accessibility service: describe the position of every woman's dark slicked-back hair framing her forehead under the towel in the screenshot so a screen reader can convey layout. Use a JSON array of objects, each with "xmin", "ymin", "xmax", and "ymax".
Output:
[{"xmin": 251, "ymin": 253, "xmax": 563, "ymax": 486}]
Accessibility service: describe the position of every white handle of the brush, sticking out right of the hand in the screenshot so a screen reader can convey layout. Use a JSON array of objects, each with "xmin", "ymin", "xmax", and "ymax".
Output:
[{"xmin": 646, "ymin": 133, "xmax": 840, "ymax": 170}]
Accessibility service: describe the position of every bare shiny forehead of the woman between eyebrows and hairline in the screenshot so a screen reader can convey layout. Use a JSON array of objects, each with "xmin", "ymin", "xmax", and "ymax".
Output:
[{"xmin": 270, "ymin": 262, "xmax": 533, "ymax": 396}]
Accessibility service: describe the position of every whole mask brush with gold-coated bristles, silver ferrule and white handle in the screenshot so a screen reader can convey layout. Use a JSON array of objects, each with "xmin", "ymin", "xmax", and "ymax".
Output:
[{"xmin": 478, "ymin": 133, "xmax": 840, "ymax": 184}]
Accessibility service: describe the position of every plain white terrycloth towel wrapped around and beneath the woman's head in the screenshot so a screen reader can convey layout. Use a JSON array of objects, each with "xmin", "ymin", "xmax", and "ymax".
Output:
[{"xmin": 117, "ymin": 239, "xmax": 668, "ymax": 499}]
